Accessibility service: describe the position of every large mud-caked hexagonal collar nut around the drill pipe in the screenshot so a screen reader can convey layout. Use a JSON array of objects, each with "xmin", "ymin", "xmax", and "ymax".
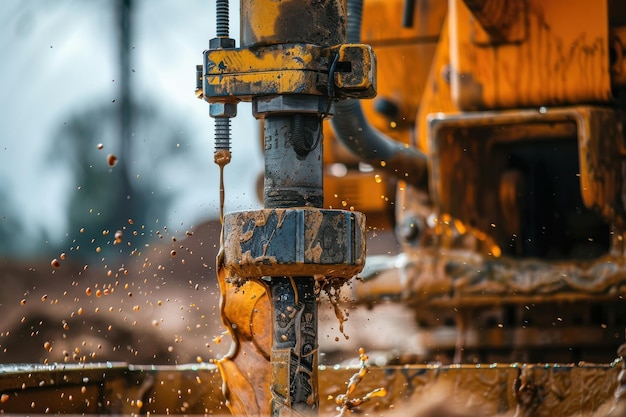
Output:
[{"xmin": 224, "ymin": 208, "xmax": 365, "ymax": 279}]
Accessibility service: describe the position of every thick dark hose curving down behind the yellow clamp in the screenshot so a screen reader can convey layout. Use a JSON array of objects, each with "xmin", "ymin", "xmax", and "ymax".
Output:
[{"xmin": 331, "ymin": 0, "xmax": 427, "ymax": 187}]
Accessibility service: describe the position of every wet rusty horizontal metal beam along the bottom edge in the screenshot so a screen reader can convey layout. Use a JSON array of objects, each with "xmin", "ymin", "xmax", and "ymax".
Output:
[{"xmin": 0, "ymin": 362, "xmax": 621, "ymax": 417}]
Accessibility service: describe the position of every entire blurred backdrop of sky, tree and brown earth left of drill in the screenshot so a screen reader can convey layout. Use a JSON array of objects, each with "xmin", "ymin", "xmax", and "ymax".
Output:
[{"xmin": 0, "ymin": 0, "xmax": 263, "ymax": 363}]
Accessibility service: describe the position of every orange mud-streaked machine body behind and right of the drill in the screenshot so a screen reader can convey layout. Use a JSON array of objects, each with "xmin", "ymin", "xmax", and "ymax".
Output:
[{"xmin": 342, "ymin": 0, "xmax": 626, "ymax": 362}]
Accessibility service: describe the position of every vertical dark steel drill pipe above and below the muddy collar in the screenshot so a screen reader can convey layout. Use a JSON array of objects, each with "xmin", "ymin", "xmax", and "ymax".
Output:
[{"xmin": 263, "ymin": 114, "xmax": 323, "ymax": 416}]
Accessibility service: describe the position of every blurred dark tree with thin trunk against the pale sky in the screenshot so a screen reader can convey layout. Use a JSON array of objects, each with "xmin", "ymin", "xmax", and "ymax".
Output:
[{"xmin": 47, "ymin": 0, "xmax": 182, "ymax": 257}]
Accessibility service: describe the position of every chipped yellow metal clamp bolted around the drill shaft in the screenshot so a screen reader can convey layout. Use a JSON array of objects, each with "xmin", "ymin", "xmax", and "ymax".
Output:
[{"xmin": 203, "ymin": 44, "xmax": 376, "ymax": 101}]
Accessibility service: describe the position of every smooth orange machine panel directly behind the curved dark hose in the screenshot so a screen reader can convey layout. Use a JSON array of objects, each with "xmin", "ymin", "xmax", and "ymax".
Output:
[{"xmin": 324, "ymin": 0, "xmax": 447, "ymax": 158}]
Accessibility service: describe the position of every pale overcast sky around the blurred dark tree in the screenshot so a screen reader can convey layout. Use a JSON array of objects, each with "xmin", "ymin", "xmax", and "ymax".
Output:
[{"xmin": 0, "ymin": 0, "xmax": 263, "ymax": 255}]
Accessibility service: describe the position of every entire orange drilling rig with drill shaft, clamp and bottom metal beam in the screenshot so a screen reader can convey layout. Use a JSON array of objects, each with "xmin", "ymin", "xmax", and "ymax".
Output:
[{"xmin": 0, "ymin": 0, "xmax": 626, "ymax": 416}]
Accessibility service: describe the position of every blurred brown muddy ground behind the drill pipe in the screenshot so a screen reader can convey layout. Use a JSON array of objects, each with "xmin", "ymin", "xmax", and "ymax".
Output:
[{"xmin": 0, "ymin": 221, "xmax": 404, "ymax": 364}]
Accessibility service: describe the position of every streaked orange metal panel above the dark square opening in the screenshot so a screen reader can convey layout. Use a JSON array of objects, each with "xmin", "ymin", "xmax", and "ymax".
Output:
[{"xmin": 449, "ymin": 0, "xmax": 611, "ymax": 110}]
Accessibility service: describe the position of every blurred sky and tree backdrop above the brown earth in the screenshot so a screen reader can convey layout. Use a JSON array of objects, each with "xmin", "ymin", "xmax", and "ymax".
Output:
[{"xmin": 0, "ymin": 0, "xmax": 263, "ymax": 258}]
